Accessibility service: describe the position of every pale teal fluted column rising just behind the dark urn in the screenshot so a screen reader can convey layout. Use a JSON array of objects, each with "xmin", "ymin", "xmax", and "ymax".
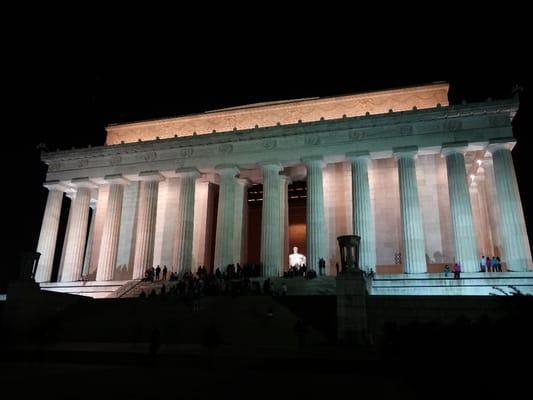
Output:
[{"xmin": 346, "ymin": 152, "xmax": 376, "ymax": 271}]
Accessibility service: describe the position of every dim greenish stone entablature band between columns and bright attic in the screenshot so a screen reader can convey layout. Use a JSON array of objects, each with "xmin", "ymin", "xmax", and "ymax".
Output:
[{"xmin": 42, "ymin": 99, "xmax": 518, "ymax": 172}]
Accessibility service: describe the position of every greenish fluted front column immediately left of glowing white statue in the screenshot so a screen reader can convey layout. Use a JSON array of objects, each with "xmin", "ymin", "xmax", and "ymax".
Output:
[{"xmin": 261, "ymin": 162, "xmax": 282, "ymax": 276}]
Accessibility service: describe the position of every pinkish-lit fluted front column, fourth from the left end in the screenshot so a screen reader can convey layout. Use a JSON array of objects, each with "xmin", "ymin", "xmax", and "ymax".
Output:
[{"xmin": 133, "ymin": 171, "xmax": 163, "ymax": 279}]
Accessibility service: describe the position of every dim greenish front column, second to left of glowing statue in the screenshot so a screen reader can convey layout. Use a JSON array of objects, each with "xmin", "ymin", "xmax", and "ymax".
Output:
[{"xmin": 214, "ymin": 165, "xmax": 239, "ymax": 272}]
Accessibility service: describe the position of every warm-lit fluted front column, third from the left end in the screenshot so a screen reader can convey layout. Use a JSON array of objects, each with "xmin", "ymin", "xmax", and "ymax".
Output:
[{"xmin": 96, "ymin": 175, "xmax": 128, "ymax": 281}]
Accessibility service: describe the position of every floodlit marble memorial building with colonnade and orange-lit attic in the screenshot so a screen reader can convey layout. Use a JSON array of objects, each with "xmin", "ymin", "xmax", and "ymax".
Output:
[{"xmin": 35, "ymin": 83, "xmax": 533, "ymax": 282}]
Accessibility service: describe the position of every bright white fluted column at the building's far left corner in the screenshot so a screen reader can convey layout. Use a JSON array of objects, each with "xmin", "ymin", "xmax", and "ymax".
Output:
[{"xmin": 35, "ymin": 181, "xmax": 65, "ymax": 282}]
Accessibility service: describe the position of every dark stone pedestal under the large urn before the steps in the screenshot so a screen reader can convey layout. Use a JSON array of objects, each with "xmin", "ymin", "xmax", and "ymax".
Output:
[{"xmin": 336, "ymin": 270, "xmax": 368, "ymax": 345}]
